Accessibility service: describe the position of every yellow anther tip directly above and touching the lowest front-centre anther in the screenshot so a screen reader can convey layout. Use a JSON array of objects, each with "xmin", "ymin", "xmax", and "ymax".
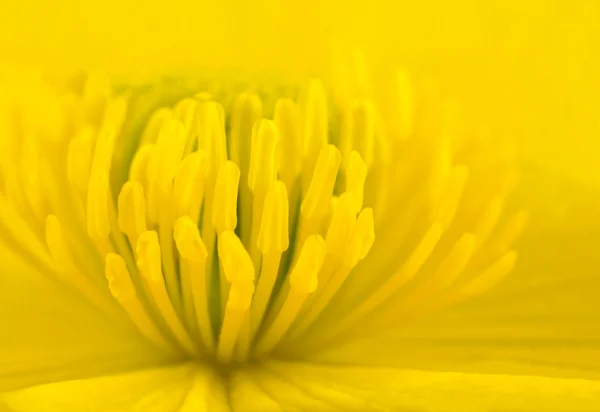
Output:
[{"xmin": 218, "ymin": 231, "xmax": 254, "ymax": 283}]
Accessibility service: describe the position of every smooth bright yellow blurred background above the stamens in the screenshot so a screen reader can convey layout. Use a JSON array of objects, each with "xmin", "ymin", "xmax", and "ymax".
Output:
[{"xmin": 0, "ymin": 0, "xmax": 600, "ymax": 184}]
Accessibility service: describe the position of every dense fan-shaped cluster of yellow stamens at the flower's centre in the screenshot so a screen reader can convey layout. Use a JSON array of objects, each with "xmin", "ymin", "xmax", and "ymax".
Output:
[{"xmin": 0, "ymin": 63, "xmax": 526, "ymax": 364}]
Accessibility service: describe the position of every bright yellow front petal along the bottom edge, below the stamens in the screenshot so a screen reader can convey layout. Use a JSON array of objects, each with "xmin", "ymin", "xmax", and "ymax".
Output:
[{"xmin": 7, "ymin": 362, "xmax": 600, "ymax": 412}]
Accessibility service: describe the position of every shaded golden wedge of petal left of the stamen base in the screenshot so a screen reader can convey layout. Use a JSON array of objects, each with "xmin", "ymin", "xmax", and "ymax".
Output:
[{"xmin": 0, "ymin": 244, "xmax": 175, "ymax": 393}]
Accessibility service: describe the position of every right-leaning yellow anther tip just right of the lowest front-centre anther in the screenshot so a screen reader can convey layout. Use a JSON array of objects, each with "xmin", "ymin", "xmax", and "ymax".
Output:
[{"xmin": 290, "ymin": 235, "xmax": 325, "ymax": 294}]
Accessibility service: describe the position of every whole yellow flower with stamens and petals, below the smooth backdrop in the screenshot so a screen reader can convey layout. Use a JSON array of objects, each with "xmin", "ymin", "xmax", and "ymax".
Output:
[{"xmin": 0, "ymin": 1, "xmax": 600, "ymax": 412}]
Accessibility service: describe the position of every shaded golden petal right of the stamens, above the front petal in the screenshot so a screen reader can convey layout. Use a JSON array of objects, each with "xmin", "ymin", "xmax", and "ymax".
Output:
[{"xmin": 314, "ymin": 166, "xmax": 600, "ymax": 379}]
